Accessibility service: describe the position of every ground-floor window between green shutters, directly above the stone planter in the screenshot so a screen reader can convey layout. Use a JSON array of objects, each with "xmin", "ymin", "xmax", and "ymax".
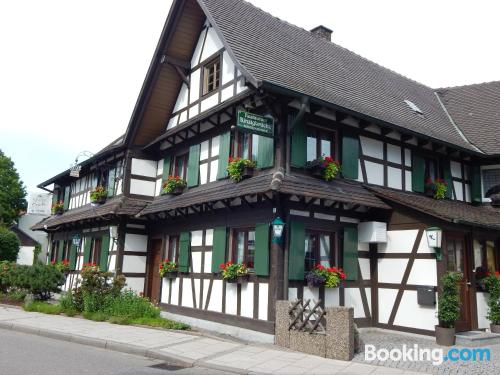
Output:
[{"xmin": 304, "ymin": 231, "xmax": 334, "ymax": 272}]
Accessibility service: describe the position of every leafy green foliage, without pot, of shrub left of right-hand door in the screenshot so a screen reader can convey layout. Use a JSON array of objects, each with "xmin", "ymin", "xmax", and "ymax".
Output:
[{"xmin": 438, "ymin": 272, "xmax": 462, "ymax": 328}]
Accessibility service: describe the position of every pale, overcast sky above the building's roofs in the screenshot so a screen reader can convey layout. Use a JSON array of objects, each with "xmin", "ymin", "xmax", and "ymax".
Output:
[{"xmin": 0, "ymin": 0, "xmax": 500, "ymax": 191}]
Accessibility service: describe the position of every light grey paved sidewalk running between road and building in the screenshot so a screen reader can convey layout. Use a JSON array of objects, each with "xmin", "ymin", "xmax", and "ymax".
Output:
[{"xmin": 0, "ymin": 305, "xmax": 428, "ymax": 375}]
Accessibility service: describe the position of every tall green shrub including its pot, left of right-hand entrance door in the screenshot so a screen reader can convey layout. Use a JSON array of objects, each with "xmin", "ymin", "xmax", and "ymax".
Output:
[{"xmin": 436, "ymin": 272, "xmax": 462, "ymax": 346}]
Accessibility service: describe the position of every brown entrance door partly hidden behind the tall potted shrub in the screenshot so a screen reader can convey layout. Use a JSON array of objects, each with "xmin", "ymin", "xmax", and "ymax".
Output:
[{"xmin": 446, "ymin": 235, "xmax": 472, "ymax": 332}]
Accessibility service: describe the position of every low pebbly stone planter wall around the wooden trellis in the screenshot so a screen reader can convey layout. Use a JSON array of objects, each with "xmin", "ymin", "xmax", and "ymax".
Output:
[{"xmin": 275, "ymin": 301, "xmax": 354, "ymax": 361}]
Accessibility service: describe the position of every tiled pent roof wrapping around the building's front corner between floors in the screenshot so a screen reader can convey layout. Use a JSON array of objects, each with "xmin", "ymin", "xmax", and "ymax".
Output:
[{"xmin": 140, "ymin": 173, "xmax": 390, "ymax": 215}]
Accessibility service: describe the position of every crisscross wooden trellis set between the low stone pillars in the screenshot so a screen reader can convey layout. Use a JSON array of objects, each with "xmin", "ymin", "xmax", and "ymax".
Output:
[{"xmin": 288, "ymin": 299, "xmax": 326, "ymax": 335}]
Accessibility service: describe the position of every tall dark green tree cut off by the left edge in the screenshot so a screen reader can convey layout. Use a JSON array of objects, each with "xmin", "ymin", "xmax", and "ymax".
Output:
[{"xmin": 0, "ymin": 150, "xmax": 27, "ymax": 226}]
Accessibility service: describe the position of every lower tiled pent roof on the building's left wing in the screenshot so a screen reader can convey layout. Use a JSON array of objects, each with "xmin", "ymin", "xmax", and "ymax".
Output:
[{"xmin": 31, "ymin": 195, "xmax": 147, "ymax": 230}]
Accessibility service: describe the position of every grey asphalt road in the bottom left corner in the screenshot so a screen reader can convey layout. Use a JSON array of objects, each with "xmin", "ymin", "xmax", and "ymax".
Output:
[{"xmin": 0, "ymin": 329, "xmax": 236, "ymax": 375}]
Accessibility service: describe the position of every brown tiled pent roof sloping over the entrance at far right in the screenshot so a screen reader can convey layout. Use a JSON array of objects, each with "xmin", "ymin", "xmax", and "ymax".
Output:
[{"xmin": 367, "ymin": 186, "xmax": 500, "ymax": 230}]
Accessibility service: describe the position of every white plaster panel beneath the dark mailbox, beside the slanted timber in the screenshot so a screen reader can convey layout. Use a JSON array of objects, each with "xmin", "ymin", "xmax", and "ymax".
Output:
[{"xmin": 394, "ymin": 290, "xmax": 438, "ymax": 331}]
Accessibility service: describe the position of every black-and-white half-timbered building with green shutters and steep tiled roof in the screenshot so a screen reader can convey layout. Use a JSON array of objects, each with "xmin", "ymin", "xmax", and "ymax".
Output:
[{"xmin": 36, "ymin": 0, "xmax": 500, "ymax": 339}]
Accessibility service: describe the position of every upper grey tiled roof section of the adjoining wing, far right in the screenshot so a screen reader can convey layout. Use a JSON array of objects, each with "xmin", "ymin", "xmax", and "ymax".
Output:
[{"xmin": 437, "ymin": 81, "xmax": 500, "ymax": 154}]
